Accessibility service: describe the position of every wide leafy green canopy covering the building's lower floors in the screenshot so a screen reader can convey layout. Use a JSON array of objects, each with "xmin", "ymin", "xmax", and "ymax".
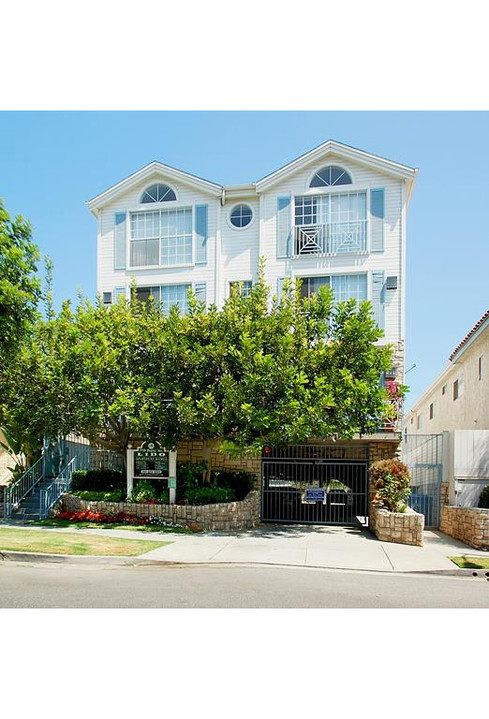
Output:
[{"xmin": 0, "ymin": 266, "xmax": 391, "ymax": 473}]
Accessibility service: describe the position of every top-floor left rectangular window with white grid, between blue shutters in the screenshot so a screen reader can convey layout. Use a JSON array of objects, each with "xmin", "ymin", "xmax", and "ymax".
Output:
[{"xmin": 131, "ymin": 207, "xmax": 192, "ymax": 267}]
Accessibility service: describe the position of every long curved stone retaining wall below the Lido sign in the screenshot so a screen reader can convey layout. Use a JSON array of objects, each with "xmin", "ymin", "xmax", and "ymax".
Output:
[{"xmin": 52, "ymin": 490, "xmax": 260, "ymax": 531}]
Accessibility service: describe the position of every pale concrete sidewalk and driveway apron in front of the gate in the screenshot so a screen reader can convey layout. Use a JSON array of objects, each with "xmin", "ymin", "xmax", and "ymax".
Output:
[{"xmin": 0, "ymin": 522, "xmax": 489, "ymax": 572}]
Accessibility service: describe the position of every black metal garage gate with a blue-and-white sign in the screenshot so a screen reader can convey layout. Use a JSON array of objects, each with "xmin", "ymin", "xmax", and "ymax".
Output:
[{"xmin": 261, "ymin": 445, "xmax": 368, "ymax": 525}]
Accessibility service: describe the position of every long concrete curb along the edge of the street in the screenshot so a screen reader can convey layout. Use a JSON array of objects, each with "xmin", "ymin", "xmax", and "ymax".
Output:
[{"xmin": 0, "ymin": 550, "xmax": 489, "ymax": 580}]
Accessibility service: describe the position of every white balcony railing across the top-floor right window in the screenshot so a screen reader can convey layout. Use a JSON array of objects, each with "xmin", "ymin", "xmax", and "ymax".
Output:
[{"xmin": 293, "ymin": 220, "xmax": 367, "ymax": 257}]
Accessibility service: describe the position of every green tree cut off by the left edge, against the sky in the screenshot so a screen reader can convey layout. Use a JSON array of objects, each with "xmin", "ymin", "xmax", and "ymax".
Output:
[{"xmin": 0, "ymin": 200, "xmax": 41, "ymax": 366}]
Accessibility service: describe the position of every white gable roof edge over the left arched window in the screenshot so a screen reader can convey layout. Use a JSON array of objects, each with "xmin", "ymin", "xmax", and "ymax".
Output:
[{"xmin": 86, "ymin": 160, "xmax": 222, "ymax": 215}]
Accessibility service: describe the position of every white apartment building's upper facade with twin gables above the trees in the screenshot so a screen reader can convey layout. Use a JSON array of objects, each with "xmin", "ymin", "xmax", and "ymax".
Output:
[{"xmin": 87, "ymin": 140, "xmax": 417, "ymax": 380}]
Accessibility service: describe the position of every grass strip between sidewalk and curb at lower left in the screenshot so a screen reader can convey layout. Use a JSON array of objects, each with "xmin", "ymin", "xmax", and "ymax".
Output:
[{"xmin": 0, "ymin": 528, "xmax": 171, "ymax": 557}]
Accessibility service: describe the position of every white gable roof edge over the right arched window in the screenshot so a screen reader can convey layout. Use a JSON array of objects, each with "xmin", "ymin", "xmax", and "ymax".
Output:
[{"xmin": 255, "ymin": 140, "xmax": 418, "ymax": 192}]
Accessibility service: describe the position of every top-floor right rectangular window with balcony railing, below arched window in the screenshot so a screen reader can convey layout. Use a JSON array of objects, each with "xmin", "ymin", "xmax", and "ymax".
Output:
[{"xmin": 294, "ymin": 192, "xmax": 367, "ymax": 256}]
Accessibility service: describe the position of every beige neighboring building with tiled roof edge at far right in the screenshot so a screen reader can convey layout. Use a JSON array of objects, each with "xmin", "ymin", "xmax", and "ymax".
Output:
[{"xmin": 404, "ymin": 310, "xmax": 489, "ymax": 435}]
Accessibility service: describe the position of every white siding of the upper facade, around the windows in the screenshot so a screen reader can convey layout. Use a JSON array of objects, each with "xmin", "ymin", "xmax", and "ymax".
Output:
[{"xmin": 97, "ymin": 154, "xmax": 405, "ymax": 352}]
